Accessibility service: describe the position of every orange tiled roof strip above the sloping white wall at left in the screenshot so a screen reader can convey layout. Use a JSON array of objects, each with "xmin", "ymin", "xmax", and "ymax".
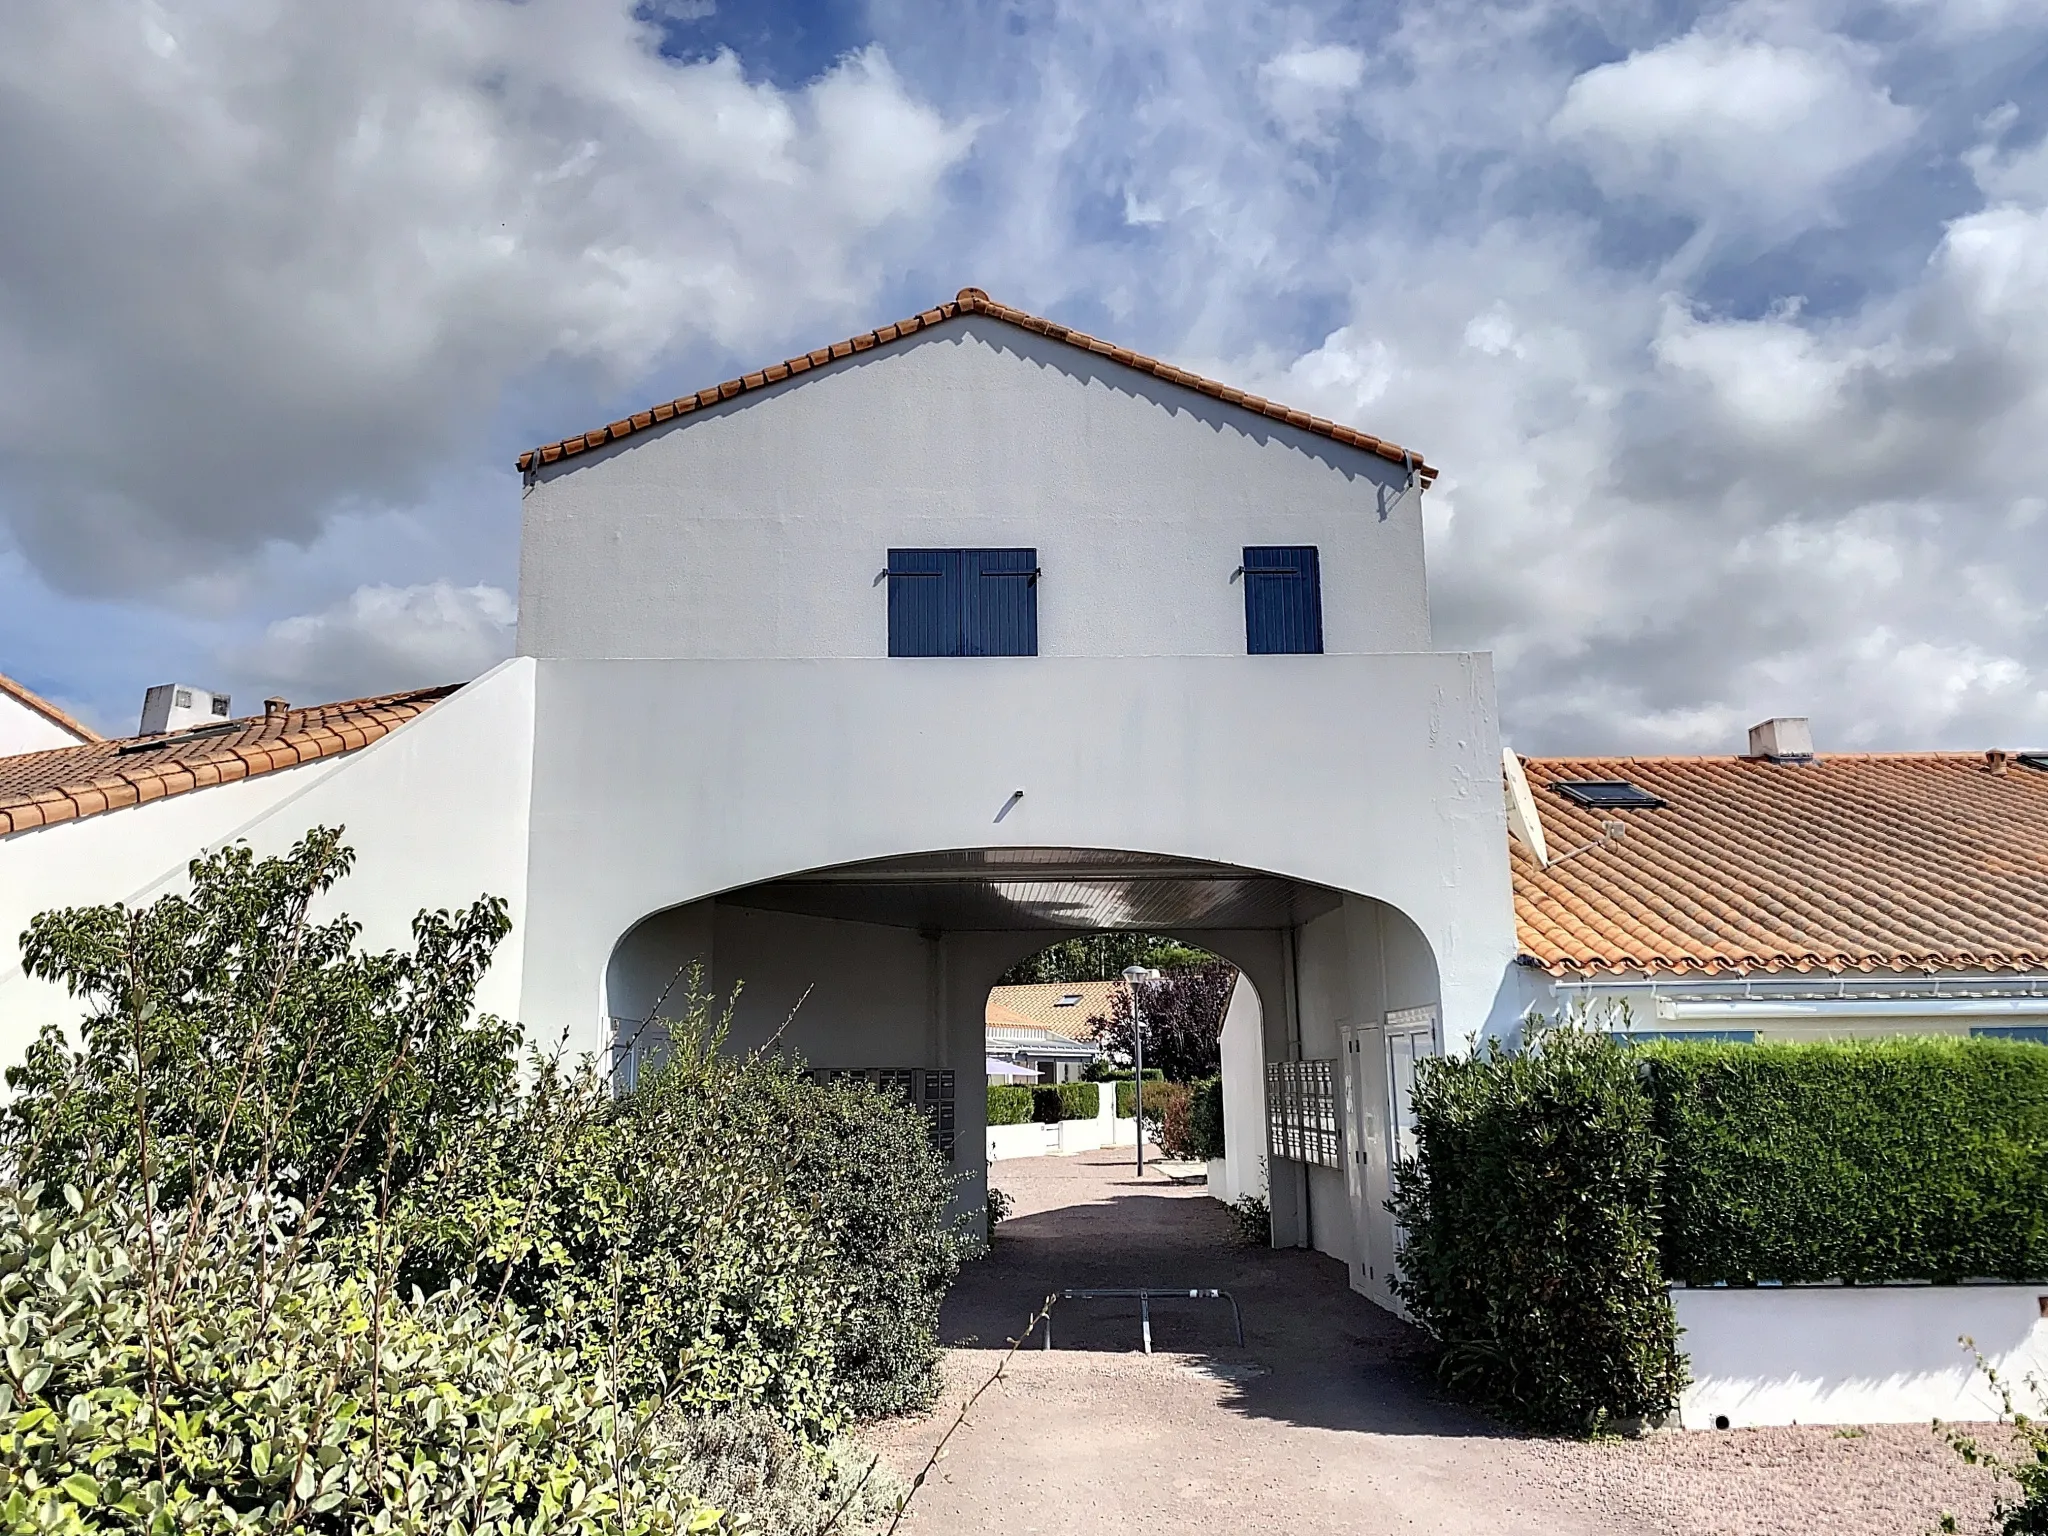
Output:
[{"xmin": 0, "ymin": 682, "xmax": 461, "ymax": 836}]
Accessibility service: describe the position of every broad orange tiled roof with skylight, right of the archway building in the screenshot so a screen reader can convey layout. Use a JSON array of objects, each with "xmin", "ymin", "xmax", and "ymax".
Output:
[{"xmin": 1511, "ymin": 752, "xmax": 2048, "ymax": 975}]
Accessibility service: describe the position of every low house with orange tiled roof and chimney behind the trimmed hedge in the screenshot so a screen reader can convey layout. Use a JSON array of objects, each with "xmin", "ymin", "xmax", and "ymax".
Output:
[{"xmin": 1505, "ymin": 719, "xmax": 2048, "ymax": 1042}]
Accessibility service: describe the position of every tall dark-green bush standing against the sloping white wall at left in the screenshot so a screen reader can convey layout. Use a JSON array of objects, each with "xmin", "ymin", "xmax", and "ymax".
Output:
[{"xmin": 6, "ymin": 827, "xmax": 520, "ymax": 1223}]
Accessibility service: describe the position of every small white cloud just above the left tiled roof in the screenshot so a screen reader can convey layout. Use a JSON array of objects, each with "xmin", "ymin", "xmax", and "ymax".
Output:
[{"xmin": 223, "ymin": 582, "xmax": 516, "ymax": 705}]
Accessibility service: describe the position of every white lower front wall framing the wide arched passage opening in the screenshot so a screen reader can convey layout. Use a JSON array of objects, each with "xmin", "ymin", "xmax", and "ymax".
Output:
[{"xmin": 522, "ymin": 655, "xmax": 1513, "ymax": 1061}]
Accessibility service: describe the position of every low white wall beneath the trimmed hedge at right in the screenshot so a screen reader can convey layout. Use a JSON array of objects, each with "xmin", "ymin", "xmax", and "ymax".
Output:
[{"xmin": 1671, "ymin": 1286, "xmax": 2048, "ymax": 1430}]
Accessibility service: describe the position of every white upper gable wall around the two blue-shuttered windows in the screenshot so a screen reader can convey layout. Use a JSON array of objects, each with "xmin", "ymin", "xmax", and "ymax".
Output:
[{"xmin": 518, "ymin": 315, "xmax": 1433, "ymax": 663}]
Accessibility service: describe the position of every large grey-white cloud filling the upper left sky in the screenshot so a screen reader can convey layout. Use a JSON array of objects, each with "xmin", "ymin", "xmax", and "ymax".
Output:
[{"xmin": 0, "ymin": 0, "xmax": 969, "ymax": 592}]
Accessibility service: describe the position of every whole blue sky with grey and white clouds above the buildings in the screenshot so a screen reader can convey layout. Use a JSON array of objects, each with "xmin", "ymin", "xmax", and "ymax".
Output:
[{"xmin": 0, "ymin": 0, "xmax": 2048, "ymax": 752}]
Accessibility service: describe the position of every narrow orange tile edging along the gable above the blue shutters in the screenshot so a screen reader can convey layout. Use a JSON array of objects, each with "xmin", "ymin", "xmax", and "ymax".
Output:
[{"xmin": 518, "ymin": 289, "xmax": 1436, "ymax": 485}]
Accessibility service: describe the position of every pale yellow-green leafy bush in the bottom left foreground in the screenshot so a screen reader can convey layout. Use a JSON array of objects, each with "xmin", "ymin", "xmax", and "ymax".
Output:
[{"xmin": 0, "ymin": 1184, "xmax": 725, "ymax": 1536}]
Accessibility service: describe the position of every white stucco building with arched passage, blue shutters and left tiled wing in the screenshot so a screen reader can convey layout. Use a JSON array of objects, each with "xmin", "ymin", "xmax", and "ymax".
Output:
[{"xmin": 0, "ymin": 289, "xmax": 1516, "ymax": 1300}]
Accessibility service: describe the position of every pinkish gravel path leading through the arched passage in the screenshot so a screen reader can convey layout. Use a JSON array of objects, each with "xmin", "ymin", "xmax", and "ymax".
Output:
[{"xmin": 872, "ymin": 1153, "xmax": 1991, "ymax": 1536}]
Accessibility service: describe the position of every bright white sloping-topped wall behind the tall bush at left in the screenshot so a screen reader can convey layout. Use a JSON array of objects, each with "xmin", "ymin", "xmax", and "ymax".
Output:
[{"xmin": 0, "ymin": 662, "xmax": 536, "ymax": 1061}]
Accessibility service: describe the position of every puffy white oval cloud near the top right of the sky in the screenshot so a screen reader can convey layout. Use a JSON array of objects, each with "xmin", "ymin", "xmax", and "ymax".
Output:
[{"xmin": 1548, "ymin": 29, "xmax": 1917, "ymax": 227}]
